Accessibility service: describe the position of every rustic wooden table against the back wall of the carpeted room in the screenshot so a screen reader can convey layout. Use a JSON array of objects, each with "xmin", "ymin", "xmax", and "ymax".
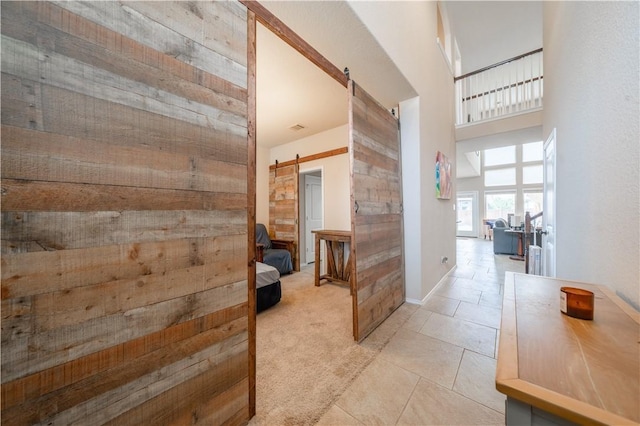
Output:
[{"xmin": 311, "ymin": 229, "xmax": 351, "ymax": 288}]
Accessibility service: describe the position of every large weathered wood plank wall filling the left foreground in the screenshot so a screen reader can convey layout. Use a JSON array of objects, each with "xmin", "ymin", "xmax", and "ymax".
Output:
[{"xmin": 1, "ymin": 1, "xmax": 250, "ymax": 425}]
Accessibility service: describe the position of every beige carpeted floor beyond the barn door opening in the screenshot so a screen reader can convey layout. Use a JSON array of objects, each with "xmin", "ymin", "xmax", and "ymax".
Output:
[{"xmin": 250, "ymin": 265, "xmax": 418, "ymax": 425}]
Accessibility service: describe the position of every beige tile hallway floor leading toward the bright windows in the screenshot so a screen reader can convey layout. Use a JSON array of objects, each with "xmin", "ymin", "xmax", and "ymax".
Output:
[{"xmin": 318, "ymin": 238, "xmax": 524, "ymax": 425}]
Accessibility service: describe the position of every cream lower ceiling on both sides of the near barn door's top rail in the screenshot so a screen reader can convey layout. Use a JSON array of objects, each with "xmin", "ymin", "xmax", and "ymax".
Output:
[{"xmin": 256, "ymin": 1, "xmax": 416, "ymax": 147}]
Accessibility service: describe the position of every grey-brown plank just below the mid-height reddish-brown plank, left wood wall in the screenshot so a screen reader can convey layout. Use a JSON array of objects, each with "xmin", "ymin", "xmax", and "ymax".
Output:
[{"xmin": 2, "ymin": 210, "xmax": 247, "ymax": 250}]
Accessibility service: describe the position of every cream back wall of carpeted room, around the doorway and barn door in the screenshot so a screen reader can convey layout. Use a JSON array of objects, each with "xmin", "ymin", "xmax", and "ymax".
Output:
[{"xmin": 256, "ymin": 124, "xmax": 351, "ymax": 230}]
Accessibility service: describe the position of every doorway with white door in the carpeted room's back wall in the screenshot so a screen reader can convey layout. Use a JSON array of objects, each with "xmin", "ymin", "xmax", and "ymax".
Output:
[{"xmin": 298, "ymin": 169, "xmax": 324, "ymax": 265}]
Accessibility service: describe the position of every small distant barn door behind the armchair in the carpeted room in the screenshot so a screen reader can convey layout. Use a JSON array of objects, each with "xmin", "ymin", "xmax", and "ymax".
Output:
[{"xmin": 269, "ymin": 164, "xmax": 300, "ymax": 271}]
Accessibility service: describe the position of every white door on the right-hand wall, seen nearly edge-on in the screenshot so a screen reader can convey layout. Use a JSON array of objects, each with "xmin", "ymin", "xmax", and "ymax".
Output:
[{"xmin": 542, "ymin": 129, "xmax": 556, "ymax": 277}]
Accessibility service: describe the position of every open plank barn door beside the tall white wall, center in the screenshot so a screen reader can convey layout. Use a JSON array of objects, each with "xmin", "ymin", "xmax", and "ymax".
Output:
[{"xmin": 348, "ymin": 80, "xmax": 404, "ymax": 341}]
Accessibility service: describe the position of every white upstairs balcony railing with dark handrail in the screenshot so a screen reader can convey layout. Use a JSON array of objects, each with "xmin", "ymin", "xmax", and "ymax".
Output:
[{"xmin": 454, "ymin": 48, "xmax": 544, "ymax": 125}]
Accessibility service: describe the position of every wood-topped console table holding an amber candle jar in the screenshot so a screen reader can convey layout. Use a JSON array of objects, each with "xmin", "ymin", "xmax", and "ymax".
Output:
[{"xmin": 496, "ymin": 272, "xmax": 640, "ymax": 425}]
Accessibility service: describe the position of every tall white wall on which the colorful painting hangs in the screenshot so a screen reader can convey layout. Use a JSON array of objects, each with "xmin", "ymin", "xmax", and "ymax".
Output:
[{"xmin": 349, "ymin": 1, "xmax": 456, "ymax": 301}]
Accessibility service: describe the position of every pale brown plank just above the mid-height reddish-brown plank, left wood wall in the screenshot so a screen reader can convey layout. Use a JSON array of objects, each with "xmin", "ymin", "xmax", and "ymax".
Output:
[{"xmin": 2, "ymin": 126, "xmax": 247, "ymax": 193}]
